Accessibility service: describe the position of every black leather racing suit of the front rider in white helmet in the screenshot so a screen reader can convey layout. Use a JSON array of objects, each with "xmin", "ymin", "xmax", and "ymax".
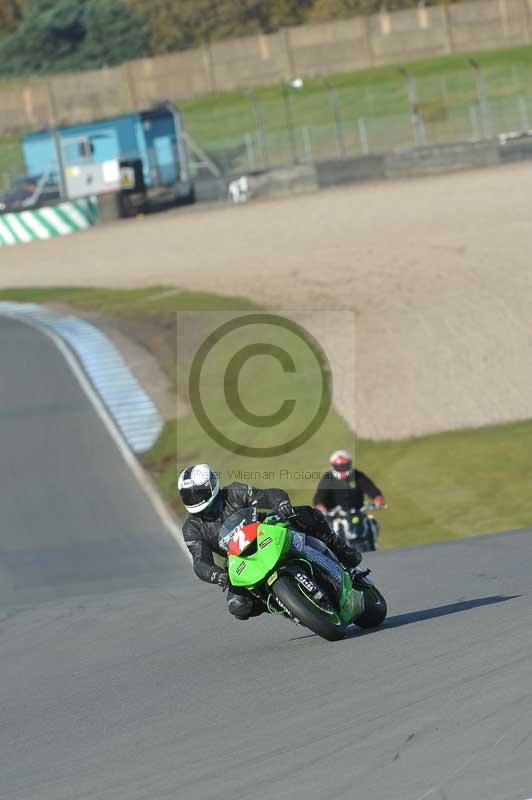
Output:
[{"xmin": 183, "ymin": 482, "xmax": 361, "ymax": 619}]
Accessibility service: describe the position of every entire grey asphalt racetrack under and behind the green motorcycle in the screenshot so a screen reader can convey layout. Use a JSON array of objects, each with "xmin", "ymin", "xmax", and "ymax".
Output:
[{"xmin": 0, "ymin": 320, "xmax": 532, "ymax": 800}]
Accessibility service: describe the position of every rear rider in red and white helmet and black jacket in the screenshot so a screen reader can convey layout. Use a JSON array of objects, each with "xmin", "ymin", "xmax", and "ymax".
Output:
[{"xmin": 313, "ymin": 450, "xmax": 386, "ymax": 514}]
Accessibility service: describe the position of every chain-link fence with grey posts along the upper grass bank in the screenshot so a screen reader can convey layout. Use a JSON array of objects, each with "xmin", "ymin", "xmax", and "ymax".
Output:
[{"xmin": 185, "ymin": 63, "xmax": 532, "ymax": 175}]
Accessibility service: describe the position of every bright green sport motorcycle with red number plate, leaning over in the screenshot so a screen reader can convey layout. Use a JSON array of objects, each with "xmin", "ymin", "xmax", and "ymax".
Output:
[{"xmin": 219, "ymin": 508, "xmax": 387, "ymax": 642}]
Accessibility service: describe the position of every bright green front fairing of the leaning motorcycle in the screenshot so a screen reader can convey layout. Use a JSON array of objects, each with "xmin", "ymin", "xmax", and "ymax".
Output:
[{"xmin": 228, "ymin": 522, "xmax": 292, "ymax": 587}]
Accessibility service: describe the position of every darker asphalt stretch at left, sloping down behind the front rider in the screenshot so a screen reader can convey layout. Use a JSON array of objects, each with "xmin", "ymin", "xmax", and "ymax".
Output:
[{"xmin": 0, "ymin": 317, "xmax": 183, "ymax": 607}]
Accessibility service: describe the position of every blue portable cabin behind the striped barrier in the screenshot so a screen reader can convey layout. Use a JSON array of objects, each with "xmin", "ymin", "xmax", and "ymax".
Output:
[{"xmin": 21, "ymin": 104, "xmax": 193, "ymax": 206}]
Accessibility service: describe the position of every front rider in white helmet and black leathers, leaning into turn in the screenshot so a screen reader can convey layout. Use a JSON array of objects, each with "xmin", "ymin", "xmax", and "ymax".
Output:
[{"xmin": 177, "ymin": 464, "xmax": 362, "ymax": 620}]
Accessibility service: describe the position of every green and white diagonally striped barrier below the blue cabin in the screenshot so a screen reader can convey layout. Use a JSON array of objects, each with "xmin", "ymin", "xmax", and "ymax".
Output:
[{"xmin": 0, "ymin": 198, "xmax": 98, "ymax": 246}]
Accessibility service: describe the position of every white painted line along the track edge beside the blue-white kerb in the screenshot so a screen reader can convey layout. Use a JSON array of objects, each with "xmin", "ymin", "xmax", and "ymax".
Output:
[{"xmin": 3, "ymin": 315, "xmax": 192, "ymax": 562}]
